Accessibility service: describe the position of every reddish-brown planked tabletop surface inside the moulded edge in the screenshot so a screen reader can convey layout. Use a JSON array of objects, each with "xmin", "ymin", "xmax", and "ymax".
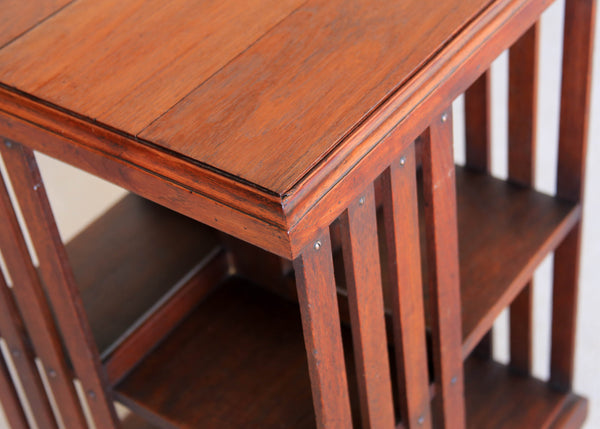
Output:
[{"xmin": 0, "ymin": 0, "xmax": 491, "ymax": 196}]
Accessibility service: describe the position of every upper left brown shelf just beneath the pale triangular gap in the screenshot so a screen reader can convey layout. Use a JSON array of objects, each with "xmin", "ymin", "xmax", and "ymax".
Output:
[{"xmin": 66, "ymin": 194, "xmax": 218, "ymax": 356}]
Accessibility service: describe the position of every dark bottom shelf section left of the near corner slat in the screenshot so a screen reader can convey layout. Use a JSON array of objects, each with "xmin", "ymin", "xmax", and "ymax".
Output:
[{"xmin": 116, "ymin": 278, "xmax": 318, "ymax": 429}]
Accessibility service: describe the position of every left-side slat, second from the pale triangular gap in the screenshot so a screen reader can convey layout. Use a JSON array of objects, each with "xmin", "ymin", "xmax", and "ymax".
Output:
[{"xmin": 0, "ymin": 142, "xmax": 85, "ymax": 428}]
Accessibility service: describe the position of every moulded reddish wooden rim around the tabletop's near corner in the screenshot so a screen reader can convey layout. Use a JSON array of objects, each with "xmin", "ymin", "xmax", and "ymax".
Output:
[{"xmin": 0, "ymin": 0, "xmax": 551, "ymax": 258}]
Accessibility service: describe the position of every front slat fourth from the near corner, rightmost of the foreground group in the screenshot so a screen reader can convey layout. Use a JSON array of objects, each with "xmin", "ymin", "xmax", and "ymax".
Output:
[{"xmin": 423, "ymin": 109, "xmax": 465, "ymax": 429}]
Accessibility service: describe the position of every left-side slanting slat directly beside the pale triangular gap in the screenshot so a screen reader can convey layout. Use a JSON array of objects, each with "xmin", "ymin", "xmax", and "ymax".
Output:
[{"xmin": 2, "ymin": 143, "xmax": 118, "ymax": 428}]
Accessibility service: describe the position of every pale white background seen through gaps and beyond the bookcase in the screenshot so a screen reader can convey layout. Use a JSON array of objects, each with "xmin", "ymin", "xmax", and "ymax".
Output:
[{"xmin": 0, "ymin": 0, "xmax": 600, "ymax": 429}]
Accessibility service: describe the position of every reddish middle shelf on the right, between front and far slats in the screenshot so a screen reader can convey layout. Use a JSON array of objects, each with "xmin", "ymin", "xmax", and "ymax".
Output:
[{"xmin": 448, "ymin": 167, "xmax": 581, "ymax": 357}]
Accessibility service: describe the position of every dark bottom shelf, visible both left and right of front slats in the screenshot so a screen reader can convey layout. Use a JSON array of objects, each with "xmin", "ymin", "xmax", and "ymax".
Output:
[{"xmin": 115, "ymin": 278, "xmax": 586, "ymax": 429}]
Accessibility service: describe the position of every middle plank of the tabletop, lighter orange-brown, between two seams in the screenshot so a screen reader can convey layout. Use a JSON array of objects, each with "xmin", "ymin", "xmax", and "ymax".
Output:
[{"xmin": 0, "ymin": 0, "xmax": 302, "ymax": 134}]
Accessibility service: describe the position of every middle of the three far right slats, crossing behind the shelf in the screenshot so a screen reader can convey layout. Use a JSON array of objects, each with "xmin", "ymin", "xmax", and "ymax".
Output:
[{"xmin": 508, "ymin": 23, "xmax": 539, "ymax": 374}]
